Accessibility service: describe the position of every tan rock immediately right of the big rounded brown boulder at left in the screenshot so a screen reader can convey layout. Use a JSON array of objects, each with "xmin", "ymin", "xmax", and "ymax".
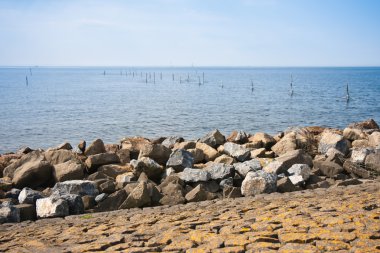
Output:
[{"xmin": 53, "ymin": 160, "xmax": 84, "ymax": 182}]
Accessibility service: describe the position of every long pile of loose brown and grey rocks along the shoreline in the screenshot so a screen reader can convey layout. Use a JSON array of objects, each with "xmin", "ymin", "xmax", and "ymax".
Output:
[{"xmin": 0, "ymin": 120, "xmax": 380, "ymax": 223}]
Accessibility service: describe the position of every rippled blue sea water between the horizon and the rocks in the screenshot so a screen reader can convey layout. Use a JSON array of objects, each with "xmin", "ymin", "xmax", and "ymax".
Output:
[{"xmin": 0, "ymin": 67, "xmax": 380, "ymax": 153}]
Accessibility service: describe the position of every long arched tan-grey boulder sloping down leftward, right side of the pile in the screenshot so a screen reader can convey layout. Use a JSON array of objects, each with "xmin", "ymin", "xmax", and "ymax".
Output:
[{"xmin": 263, "ymin": 149, "xmax": 313, "ymax": 175}]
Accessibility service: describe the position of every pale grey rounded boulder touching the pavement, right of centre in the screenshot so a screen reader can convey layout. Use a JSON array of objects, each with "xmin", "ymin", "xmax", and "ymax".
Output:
[{"xmin": 241, "ymin": 170, "xmax": 277, "ymax": 196}]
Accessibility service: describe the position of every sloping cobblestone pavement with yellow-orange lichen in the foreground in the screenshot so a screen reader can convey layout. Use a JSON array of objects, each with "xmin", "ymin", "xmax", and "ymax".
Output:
[{"xmin": 0, "ymin": 181, "xmax": 380, "ymax": 253}]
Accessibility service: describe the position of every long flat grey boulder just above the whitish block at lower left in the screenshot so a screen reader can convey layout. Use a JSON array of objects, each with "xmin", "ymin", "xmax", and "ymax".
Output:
[{"xmin": 53, "ymin": 180, "xmax": 99, "ymax": 197}]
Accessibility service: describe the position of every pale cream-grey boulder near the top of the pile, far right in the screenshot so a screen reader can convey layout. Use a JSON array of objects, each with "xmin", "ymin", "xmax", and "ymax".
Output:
[{"xmin": 318, "ymin": 131, "xmax": 351, "ymax": 154}]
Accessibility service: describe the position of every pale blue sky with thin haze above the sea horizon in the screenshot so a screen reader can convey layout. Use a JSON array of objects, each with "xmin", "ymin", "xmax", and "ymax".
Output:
[{"xmin": 0, "ymin": 0, "xmax": 380, "ymax": 66}]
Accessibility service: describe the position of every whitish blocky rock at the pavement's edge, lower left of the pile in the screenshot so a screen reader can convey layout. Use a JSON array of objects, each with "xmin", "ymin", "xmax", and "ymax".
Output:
[{"xmin": 36, "ymin": 196, "xmax": 69, "ymax": 218}]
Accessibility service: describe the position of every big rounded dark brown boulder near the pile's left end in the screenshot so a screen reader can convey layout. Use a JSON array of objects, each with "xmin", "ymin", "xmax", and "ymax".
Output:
[{"xmin": 12, "ymin": 160, "xmax": 53, "ymax": 188}]
